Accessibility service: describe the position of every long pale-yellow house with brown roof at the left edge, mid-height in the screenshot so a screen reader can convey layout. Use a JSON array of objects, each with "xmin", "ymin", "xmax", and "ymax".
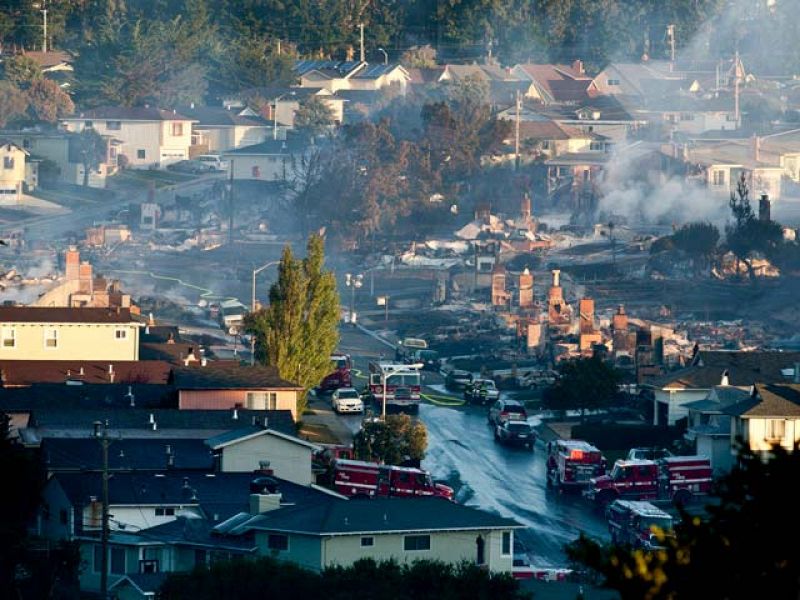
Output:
[{"xmin": 0, "ymin": 306, "xmax": 139, "ymax": 361}]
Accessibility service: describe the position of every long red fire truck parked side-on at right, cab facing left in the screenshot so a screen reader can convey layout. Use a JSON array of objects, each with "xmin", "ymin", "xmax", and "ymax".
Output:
[{"xmin": 585, "ymin": 456, "xmax": 712, "ymax": 505}]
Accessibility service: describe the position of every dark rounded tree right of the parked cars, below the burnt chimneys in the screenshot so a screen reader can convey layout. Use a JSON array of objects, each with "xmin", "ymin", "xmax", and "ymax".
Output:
[{"xmin": 543, "ymin": 357, "xmax": 620, "ymax": 419}]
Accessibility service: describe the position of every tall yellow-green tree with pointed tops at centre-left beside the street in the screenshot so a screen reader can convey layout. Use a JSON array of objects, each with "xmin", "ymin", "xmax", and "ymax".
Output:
[{"xmin": 245, "ymin": 235, "xmax": 339, "ymax": 415}]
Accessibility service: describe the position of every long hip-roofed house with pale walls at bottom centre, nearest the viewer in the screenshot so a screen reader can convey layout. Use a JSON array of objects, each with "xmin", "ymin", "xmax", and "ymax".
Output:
[{"xmin": 230, "ymin": 497, "xmax": 522, "ymax": 573}]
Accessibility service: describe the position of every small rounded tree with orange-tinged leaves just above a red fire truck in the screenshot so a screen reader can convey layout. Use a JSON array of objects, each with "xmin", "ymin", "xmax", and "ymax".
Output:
[{"xmin": 353, "ymin": 414, "xmax": 428, "ymax": 465}]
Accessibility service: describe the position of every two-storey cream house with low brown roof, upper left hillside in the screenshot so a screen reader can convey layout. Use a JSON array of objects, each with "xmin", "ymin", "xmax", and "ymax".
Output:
[{"xmin": 61, "ymin": 106, "xmax": 193, "ymax": 169}]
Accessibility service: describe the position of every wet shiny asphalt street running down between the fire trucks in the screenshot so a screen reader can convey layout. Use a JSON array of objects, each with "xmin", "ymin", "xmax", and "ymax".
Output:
[{"xmin": 339, "ymin": 326, "xmax": 608, "ymax": 568}]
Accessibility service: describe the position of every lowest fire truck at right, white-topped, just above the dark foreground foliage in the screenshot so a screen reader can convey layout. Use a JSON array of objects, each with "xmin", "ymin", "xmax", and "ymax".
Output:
[{"xmin": 606, "ymin": 500, "xmax": 672, "ymax": 550}]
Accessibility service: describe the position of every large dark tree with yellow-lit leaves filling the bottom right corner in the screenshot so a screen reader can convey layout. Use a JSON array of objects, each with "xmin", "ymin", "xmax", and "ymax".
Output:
[{"xmin": 567, "ymin": 446, "xmax": 800, "ymax": 600}]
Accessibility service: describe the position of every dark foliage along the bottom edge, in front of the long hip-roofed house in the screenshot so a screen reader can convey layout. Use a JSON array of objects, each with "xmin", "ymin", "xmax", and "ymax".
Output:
[{"xmin": 160, "ymin": 558, "xmax": 530, "ymax": 600}]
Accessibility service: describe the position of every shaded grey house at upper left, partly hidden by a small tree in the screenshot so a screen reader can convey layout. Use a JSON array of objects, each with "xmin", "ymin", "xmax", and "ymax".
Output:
[{"xmin": 3, "ymin": 131, "xmax": 121, "ymax": 188}]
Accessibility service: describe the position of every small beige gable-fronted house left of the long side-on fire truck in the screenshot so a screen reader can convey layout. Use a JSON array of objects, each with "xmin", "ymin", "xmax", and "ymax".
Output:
[{"xmin": 206, "ymin": 427, "xmax": 321, "ymax": 485}]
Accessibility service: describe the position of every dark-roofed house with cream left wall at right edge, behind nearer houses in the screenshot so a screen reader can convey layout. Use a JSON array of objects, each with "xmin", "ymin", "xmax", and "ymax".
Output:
[{"xmin": 642, "ymin": 350, "xmax": 800, "ymax": 425}]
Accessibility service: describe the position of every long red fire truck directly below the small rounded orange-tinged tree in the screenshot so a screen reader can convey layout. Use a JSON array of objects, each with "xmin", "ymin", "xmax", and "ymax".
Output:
[{"xmin": 333, "ymin": 459, "xmax": 453, "ymax": 500}]
